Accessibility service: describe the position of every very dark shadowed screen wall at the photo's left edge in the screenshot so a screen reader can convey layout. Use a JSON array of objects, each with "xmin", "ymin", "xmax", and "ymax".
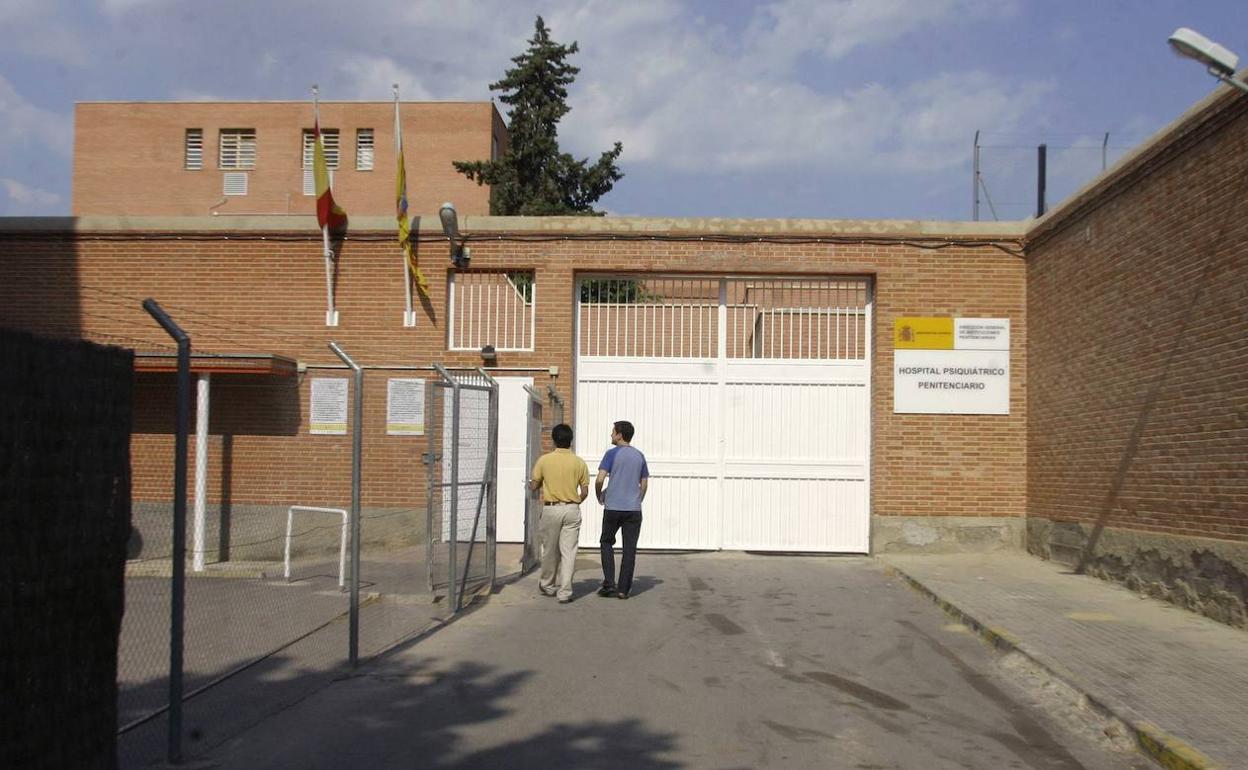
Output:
[{"xmin": 0, "ymin": 329, "xmax": 132, "ymax": 768}]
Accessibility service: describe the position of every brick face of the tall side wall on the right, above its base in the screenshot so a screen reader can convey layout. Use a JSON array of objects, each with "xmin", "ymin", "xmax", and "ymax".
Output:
[{"xmin": 1027, "ymin": 99, "xmax": 1248, "ymax": 546}]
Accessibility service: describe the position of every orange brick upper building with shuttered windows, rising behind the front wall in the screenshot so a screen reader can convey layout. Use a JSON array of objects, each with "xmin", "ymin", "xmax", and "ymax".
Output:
[{"xmin": 72, "ymin": 101, "xmax": 507, "ymax": 216}]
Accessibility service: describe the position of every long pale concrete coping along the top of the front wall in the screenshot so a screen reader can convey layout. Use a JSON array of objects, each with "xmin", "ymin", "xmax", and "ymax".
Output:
[{"xmin": 0, "ymin": 213, "xmax": 1026, "ymax": 240}]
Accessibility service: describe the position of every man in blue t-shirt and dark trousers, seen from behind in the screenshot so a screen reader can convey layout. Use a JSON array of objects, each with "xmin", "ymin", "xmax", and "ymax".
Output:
[{"xmin": 594, "ymin": 421, "xmax": 650, "ymax": 599}]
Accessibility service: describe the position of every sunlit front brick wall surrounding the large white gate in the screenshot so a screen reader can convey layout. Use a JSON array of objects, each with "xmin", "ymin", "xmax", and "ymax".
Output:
[{"xmin": 0, "ymin": 218, "xmax": 1028, "ymax": 546}]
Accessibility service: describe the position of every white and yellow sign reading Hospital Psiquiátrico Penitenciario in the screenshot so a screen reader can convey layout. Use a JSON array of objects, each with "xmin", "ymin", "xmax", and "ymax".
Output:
[{"xmin": 892, "ymin": 317, "xmax": 1010, "ymax": 414}]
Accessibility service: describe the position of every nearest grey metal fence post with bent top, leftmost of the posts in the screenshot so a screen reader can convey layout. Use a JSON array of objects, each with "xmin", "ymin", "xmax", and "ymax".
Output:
[{"xmin": 144, "ymin": 298, "xmax": 191, "ymax": 765}]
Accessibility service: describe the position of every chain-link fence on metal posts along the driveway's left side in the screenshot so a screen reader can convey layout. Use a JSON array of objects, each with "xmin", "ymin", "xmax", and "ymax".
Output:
[{"xmin": 117, "ymin": 304, "xmax": 498, "ymax": 766}]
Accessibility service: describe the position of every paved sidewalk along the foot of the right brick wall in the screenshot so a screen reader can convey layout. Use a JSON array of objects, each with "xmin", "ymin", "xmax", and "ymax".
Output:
[{"xmin": 882, "ymin": 553, "xmax": 1248, "ymax": 769}]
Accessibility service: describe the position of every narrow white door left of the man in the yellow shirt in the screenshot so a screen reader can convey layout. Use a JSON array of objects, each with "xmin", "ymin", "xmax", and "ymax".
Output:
[{"xmin": 494, "ymin": 377, "xmax": 533, "ymax": 543}]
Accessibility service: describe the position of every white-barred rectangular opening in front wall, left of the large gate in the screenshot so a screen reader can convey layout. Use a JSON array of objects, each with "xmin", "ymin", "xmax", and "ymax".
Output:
[{"xmin": 447, "ymin": 271, "xmax": 537, "ymax": 351}]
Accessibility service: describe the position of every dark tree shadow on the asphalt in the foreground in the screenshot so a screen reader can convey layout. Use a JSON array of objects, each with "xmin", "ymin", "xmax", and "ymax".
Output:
[{"xmin": 192, "ymin": 645, "xmax": 679, "ymax": 770}]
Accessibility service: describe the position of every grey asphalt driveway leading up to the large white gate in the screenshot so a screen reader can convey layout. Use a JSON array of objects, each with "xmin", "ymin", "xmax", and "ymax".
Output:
[{"xmin": 210, "ymin": 554, "xmax": 1151, "ymax": 770}]
